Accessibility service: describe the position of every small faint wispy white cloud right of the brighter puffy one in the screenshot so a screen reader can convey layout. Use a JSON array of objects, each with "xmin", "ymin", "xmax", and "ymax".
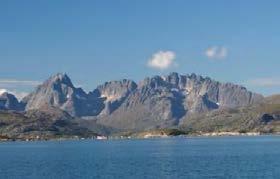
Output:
[{"xmin": 205, "ymin": 46, "xmax": 228, "ymax": 59}]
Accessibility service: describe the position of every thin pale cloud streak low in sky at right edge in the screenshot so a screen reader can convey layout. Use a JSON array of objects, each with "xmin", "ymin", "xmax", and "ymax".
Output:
[{"xmin": 247, "ymin": 78, "xmax": 280, "ymax": 87}]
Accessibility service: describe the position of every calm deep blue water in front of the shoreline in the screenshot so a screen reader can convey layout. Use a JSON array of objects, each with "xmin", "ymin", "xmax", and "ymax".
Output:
[{"xmin": 0, "ymin": 136, "xmax": 280, "ymax": 179}]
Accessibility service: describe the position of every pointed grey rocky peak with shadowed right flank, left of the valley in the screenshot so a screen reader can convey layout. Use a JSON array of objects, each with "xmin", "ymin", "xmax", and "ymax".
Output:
[{"xmin": 23, "ymin": 73, "xmax": 101, "ymax": 116}]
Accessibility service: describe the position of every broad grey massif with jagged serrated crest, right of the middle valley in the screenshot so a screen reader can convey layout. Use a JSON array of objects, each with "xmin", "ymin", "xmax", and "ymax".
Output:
[{"xmin": 96, "ymin": 73, "xmax": 263, "ymax": 129}]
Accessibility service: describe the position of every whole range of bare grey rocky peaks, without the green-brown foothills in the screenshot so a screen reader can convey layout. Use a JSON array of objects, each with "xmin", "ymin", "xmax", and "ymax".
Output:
[{"xmin": 0, "ymin": 72, "xmax": 278, "ymax": 139}]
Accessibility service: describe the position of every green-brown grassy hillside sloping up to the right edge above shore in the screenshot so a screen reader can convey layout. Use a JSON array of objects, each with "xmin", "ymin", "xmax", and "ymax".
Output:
[{"xmin": 180, "ymin": 96, "xmax": 280, "ymax": 133}]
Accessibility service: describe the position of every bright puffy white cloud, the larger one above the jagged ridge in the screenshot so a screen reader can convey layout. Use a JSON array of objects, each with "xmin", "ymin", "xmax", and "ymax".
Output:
[{"xmin": 147, "ymin": 51, "xmax": 177, "ymax": 70}]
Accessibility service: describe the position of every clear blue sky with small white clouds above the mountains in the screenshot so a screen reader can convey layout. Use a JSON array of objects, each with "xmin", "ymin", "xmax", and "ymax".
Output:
[{"xmin": 0, "ymin": 0, "xmax": 280, "ymax": 98}]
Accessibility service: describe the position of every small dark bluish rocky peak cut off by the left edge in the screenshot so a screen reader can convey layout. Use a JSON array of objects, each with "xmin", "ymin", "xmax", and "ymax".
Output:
[{"xmin": 0, "ymin": 92, "xmax": 24, "ymax": 111}]
